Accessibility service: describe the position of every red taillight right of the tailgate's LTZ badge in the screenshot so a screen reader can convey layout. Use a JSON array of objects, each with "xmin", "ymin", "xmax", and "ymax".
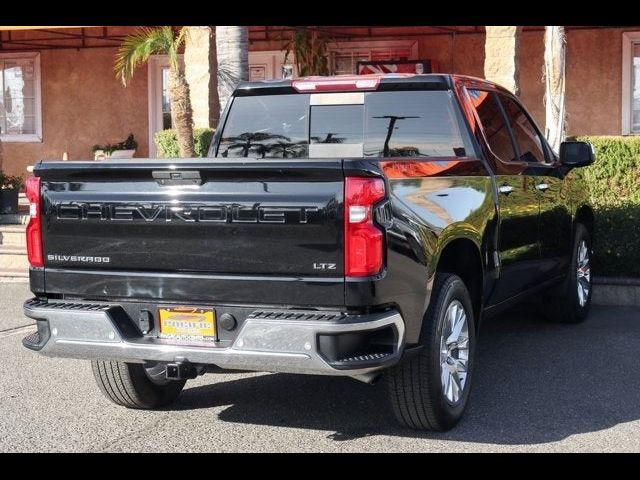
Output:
[{"xmin": 344, "ymin": 177, "xmax": 385, "ymax": 277}]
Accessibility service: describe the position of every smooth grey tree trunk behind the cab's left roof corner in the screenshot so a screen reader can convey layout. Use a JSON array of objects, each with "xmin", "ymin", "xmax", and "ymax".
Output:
[{"xmin": 216, "ymin": 26, "xmax": 249, "ymax": 116}]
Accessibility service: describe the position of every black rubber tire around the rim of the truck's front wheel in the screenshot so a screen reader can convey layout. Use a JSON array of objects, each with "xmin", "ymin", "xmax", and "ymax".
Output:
[{"xmin": 547, "ymin": 223, "xmax": 593, "ymax": 323}]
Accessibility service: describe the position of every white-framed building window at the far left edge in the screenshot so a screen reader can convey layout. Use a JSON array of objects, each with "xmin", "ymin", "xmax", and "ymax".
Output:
[{"xmin": 0, "ymin": 53, "xmax": 42, "ymax": 142}]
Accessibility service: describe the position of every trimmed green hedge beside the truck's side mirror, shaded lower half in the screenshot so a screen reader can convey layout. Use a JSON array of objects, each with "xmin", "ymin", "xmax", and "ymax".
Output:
[{"xmin": 574, "ymin": 137, "xmax": 640, "ymax": 277}]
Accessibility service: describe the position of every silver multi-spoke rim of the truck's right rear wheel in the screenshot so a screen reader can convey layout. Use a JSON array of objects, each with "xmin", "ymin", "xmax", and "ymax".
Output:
[{"xmin": 440, "ymin": 300, "xmax": 469, "ymax": 404}]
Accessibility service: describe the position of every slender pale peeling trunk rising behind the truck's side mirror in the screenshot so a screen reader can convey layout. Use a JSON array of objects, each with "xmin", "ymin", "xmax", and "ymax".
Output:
[{"xmin": 544, "ymin": 27, "xmax": 567, "ymax": 153}]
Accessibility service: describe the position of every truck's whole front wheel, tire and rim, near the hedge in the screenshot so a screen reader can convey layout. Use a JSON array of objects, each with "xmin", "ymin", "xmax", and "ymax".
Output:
[{"xmin": 548, "ymin": 223, "xmax": 593, "ymax": 323}]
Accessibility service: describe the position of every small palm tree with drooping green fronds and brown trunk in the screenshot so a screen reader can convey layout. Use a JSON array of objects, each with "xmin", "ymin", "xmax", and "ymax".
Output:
[{"xmin": 115, "ymin": 27, "xmax": 195, "ymax": 158}]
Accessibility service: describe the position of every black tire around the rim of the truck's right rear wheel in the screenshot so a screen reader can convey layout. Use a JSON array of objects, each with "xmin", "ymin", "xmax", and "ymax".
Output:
[{"xmin": 385, "ymin": 273, "xmax": 475, "ymax": 431}]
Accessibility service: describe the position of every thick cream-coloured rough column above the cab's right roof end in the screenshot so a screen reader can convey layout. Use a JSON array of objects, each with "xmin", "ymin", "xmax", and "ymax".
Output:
[{"xmin": 484, "ymin": 26, "xmax": 522, "ymax": 95}]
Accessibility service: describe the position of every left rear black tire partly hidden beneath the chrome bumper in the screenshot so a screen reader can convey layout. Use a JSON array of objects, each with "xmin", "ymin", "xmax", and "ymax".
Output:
[{"xmin": 91, "ymin": 360, "xmax": 186, "ymax": 410}]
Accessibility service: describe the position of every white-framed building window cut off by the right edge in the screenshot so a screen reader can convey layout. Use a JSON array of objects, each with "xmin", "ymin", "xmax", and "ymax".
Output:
[{"xmin": 622, "ymin": 32, "xmax": 640, "ymax": 135}]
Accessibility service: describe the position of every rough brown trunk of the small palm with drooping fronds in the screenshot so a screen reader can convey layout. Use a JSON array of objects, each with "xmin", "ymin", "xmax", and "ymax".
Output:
[{"xmin": 169, "ymin": 68, "xmax": 196, "ymax": 158}]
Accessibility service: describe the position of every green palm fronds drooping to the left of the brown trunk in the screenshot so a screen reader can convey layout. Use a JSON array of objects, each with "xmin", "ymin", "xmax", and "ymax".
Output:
[{"xmin": 114, "ymin": 27, "xmax": 177, "ymax": 85}]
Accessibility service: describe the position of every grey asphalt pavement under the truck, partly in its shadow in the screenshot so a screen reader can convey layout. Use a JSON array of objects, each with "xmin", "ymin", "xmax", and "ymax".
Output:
[{"xmin": 0, "ymin": 283, "xmax": 640, "ymax": 452}]
